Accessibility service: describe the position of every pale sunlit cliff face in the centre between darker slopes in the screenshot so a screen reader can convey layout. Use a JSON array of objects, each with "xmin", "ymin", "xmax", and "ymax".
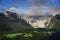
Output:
[{"xmin": 21, "ymin": 16, "xmax": 52, "ymax": 28}]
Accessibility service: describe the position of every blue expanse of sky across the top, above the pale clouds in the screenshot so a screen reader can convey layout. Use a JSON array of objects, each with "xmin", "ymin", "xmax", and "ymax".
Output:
[{"xmin": 0, "ymin": 0, "xmax": 60, "ymax": 13}]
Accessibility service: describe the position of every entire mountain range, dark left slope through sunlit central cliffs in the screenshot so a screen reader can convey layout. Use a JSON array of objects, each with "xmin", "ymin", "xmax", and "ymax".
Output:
[{"xmin": 0, "ymin": 11, "xmax": 60, "ymax": 32}]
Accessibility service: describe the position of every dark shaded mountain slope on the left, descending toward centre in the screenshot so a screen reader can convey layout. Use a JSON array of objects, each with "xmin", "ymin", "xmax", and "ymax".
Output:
[{"xmin": 0, "ymin": 12, "xmax": 32, "ymax": 33}]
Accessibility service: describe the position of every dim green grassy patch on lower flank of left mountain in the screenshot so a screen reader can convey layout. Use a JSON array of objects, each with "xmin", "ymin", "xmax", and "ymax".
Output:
[{"xmin": 9, "ymin": 22, "xmax": 26, "ymax": 32}]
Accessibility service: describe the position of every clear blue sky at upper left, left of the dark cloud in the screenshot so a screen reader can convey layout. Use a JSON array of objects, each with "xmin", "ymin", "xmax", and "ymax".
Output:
[{"xmin": 0, "ymin": 0, "xmax": 31, "ymax": 9}]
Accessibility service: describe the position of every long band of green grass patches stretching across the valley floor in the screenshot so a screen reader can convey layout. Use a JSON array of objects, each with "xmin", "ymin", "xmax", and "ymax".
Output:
[{"xmin": 0, "ymin": 31, "xmax": 53, "ymax": 38}]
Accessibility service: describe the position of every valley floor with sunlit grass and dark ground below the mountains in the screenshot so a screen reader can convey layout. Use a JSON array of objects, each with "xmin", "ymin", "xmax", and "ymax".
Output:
[{"xmin": 0, "ymin": 30, "xmax": 54, "ymax": 40}]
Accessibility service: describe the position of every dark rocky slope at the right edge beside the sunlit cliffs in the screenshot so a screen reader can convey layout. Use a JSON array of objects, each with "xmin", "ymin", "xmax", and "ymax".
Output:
[{"xmin": 48, "ymin": 14, "xmax": 60, "ymax": 31}]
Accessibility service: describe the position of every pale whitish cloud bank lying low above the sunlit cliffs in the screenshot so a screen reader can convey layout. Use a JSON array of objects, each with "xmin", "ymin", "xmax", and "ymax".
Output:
[{"xmin": 23, "ymin": 6, "xmax": 58, "ymax": 15}]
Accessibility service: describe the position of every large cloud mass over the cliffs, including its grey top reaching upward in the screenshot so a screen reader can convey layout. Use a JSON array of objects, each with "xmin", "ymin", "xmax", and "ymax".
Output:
[{"xmin": 23, "ymin": 0, "xmax": 60, "ymax": 16}]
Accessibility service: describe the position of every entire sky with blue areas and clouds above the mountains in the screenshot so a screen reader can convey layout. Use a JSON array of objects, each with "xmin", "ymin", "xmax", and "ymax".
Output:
[{"xmin": 0, "ymin": 0, "xmax": 60, "ymax": 15}]
